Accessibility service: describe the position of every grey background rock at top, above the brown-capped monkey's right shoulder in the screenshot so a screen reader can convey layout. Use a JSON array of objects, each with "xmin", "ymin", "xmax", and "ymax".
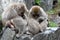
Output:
[{"xmin": 40, "ymin": 0, "xmax": 53, "ymax": 11}]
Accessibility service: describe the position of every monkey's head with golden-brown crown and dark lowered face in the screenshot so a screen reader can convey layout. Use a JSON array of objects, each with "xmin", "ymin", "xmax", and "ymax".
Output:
[{"xmin": 29, "ymin": 6, "xmax": 40, "ymax": 19}]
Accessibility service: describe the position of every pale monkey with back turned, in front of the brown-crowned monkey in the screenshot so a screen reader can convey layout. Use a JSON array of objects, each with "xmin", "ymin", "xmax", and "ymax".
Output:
[{"xmin": 27, "ymin": 19, "xmax": 43, "ymax": 35}]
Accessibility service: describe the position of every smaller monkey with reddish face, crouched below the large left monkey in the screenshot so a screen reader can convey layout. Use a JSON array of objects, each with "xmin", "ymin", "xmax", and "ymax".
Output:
[{"xmin": 1, "ymin": 16, "xmax": 27, "ymax": 38}]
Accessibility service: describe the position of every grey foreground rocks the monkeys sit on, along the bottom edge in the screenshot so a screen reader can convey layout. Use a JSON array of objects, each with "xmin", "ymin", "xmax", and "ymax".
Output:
[{"xmin": 1, "ymin": 27, "xmax": 60, "ymax": 40}]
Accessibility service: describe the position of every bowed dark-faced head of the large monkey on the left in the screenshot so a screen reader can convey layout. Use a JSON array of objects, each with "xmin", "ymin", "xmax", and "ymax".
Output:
[{"xmin": 9, "ymin": 3, "xmax": 28, "ymax": 18}]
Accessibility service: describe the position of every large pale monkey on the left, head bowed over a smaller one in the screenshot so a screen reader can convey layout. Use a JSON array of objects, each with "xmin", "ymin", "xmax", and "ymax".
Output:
[{"xmin": 2, "ymin": 3, "xmax": 28, "ymax": 25}]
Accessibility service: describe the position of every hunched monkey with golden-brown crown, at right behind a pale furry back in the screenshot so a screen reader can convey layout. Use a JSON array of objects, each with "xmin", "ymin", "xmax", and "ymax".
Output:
[{"xmin": 28, "ymin": 6, "xmax": 48, "ymax": 30}]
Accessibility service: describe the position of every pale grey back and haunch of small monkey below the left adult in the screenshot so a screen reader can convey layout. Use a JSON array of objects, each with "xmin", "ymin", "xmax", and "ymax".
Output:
[{"xmin": 11, "ymin": 17, "xmax": 27, "ymax": 37}]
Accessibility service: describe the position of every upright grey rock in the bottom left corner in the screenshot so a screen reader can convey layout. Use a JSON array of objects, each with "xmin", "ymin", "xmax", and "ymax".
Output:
[{"xmin": 1, "ymin": 28, "xmax": 15, "ymax": 40}]
